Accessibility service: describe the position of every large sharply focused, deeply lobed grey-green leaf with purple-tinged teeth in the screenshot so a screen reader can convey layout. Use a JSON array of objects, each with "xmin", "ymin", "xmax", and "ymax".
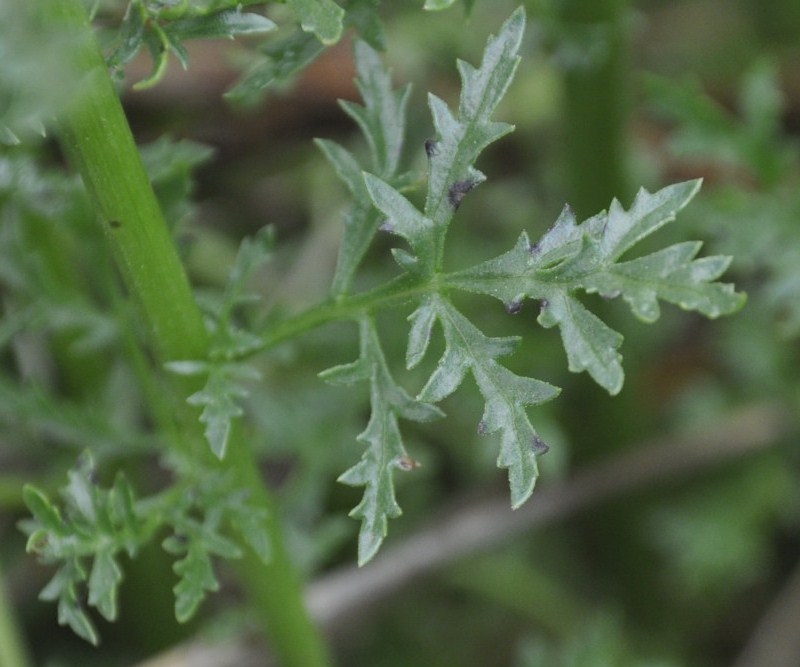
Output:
[{"xmin": 320, "ymin": 3, "xmax": 744, "ymax": 564}]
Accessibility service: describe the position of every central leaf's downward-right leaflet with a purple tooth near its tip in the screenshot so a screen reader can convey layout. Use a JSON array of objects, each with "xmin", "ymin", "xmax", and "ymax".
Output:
[{"xmin": 412, "ymin": 296, "xmax": 559, "ymax": 508}]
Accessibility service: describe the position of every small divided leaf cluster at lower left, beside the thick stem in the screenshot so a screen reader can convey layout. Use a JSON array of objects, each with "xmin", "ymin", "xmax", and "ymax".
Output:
[{"xmin": 20, "ymin": 452, "xmax": 269, "ymax": 644}]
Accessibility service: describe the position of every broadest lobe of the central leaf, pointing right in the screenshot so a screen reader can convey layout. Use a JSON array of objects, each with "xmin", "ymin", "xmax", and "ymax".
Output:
[{"xmin": 442, "ymin": 181, "xmax": 744, "ymax": 394}]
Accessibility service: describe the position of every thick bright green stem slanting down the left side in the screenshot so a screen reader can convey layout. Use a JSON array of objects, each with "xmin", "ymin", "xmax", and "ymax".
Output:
[{"xmin": 51, "ymin": 0, "xmax": 329, "ymax": 667}]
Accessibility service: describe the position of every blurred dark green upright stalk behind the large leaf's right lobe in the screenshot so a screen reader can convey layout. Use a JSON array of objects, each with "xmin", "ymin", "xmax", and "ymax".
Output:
[{"xmin": 560, "ymin": 0, "xmax": 631, "ymax": 219}]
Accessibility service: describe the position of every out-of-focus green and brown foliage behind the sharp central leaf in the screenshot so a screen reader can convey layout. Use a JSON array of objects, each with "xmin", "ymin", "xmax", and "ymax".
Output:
[{"xmin": 0, "ymin": 0, "xmax": 800, "ymax": 667}]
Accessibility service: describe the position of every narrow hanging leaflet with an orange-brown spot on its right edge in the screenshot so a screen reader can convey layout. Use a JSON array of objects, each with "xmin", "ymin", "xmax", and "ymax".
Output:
[{"xmin": 322, "ymin": 316, "xmax": 442, "ymax": 565}]
